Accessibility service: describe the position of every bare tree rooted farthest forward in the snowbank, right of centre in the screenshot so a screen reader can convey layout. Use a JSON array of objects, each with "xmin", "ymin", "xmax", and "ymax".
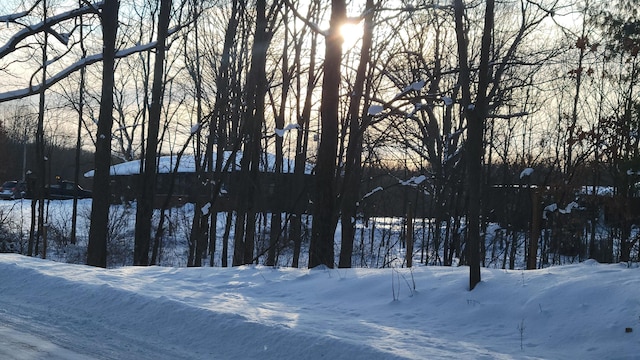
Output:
[{"xmin": 454, "ymin": 1, "xmax": 554, "ymax": 290}]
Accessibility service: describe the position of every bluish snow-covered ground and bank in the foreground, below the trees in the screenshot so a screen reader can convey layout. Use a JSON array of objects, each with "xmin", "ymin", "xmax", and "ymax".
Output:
[{"xmin": 0, "ymin": 254, "xmax": 640, "ymax": 360}]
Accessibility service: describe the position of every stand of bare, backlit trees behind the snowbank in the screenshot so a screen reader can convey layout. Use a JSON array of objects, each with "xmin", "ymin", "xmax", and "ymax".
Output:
[{"xmin": 0, "ymin": 0, "xmax": 640, "ymax": 289}]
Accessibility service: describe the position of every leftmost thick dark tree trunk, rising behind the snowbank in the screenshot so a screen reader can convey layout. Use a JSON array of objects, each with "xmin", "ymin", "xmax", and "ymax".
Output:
[{"xmin": 87, "ymin": 0, "xmax": 120, "ymax": 267}]
